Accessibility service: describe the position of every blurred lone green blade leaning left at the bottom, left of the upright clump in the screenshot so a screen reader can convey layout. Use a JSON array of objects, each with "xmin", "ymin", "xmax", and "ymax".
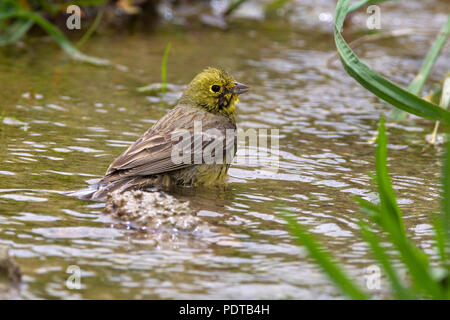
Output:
[{"xmin": 284, "ymin": 214, "xmax": 368, "ymax": 300}]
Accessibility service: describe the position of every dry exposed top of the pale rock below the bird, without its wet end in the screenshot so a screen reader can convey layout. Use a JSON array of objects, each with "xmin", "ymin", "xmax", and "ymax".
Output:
[{"xmin": 104, "ymin": 190, "xmax": 206, "ymax": 232}]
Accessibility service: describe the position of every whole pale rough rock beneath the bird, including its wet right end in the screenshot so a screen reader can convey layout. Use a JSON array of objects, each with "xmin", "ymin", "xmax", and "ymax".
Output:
[{"xmin": 104, "ymin": 190, "xmax": 240, "ymax": 248}]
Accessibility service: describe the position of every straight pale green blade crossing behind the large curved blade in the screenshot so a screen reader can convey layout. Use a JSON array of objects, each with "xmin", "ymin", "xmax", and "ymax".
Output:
[{"xmin": 391, "ymin": 15, "xmax": 450, "ymax": 121}]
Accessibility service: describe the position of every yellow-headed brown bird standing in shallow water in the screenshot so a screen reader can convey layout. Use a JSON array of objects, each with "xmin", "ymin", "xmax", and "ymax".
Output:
[{"xmin": 82, "ymin": 67, "xmax": 249, "ymax": 200}]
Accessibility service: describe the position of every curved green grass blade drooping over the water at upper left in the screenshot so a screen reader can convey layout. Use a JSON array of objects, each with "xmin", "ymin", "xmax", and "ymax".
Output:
[{"xmin": 0, "ymin": 10, "xmax": 110, "ymax": 66}]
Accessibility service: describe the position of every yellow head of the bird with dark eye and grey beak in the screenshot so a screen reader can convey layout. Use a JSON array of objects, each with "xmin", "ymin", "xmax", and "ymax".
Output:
[{"xmin": 180, "ymin": 68, "xmax": 249, "ymax": 120}]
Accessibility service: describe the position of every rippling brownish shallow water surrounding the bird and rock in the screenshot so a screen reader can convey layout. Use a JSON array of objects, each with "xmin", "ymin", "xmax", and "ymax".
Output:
[{"xmin": 0, "ymin": 1, "xmax": 450, "ymax": 299}]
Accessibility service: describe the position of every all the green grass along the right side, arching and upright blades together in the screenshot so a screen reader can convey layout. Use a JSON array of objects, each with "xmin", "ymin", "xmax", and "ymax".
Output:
[{"xmin": 283, "ymin": 0, "xmax": 450, "ymax": 299}]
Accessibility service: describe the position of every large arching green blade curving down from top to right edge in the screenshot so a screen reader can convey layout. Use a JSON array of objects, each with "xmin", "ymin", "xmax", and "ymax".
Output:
[{"xmin": 334, "ymin": 0, "xmax": 450, "ymax": 124}]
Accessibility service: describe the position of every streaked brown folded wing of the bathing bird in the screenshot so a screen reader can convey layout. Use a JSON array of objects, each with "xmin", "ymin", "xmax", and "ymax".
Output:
[{"xmin": 100, "ymin": 108, "xmax": 234, "ymax": 183}]
